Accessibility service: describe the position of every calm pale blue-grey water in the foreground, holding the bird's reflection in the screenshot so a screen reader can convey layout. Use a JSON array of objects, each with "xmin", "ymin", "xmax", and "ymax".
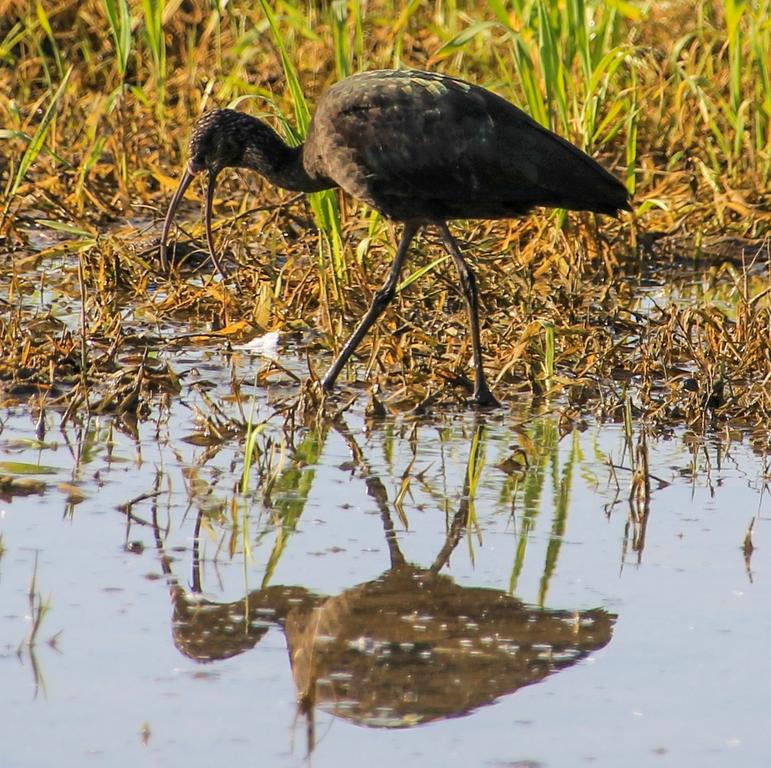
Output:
[{"xmin": 0, "ymin": 332, "xmax": 771, "ymax": 767}]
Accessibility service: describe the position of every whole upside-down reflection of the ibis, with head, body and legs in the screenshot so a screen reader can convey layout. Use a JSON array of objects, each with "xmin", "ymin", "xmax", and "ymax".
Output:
[{"xmin": 156, "ymin": 420, "xmax": 616, "ymax": 749}]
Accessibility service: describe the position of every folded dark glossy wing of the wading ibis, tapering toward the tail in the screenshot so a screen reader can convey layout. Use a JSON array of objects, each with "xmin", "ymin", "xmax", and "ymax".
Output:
[{"xmin": 308, "ymin": 72, "xmax": 618, "ymax": 215}]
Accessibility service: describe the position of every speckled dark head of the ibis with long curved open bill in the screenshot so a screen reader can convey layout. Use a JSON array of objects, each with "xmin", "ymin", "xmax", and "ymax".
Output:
[{"xmin": 160, "ymin": 109, "xmax": 285, "ymax": 278}]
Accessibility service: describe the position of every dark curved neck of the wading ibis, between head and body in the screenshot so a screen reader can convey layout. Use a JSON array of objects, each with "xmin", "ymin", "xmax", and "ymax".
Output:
[{"xmin": 243, "ymin": 123, "xmax": 337, "ymax": 192}]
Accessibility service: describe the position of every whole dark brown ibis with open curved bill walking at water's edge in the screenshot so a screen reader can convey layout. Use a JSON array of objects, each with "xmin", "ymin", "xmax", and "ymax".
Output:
[{"xmin": 161, "ymin": 70, "xmax": 630, "ymax": 406}]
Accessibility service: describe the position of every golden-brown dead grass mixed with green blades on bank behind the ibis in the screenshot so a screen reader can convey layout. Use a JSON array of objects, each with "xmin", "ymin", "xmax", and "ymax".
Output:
[{"xmin": 0, "ymin": 0, "xmax": 771, "ymax": 438}]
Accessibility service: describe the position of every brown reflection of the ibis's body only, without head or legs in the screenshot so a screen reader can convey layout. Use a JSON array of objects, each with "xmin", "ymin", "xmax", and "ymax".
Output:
[{"xmin": 284, "ymin": 564, "xmax": 612, "ymax": 728}]
